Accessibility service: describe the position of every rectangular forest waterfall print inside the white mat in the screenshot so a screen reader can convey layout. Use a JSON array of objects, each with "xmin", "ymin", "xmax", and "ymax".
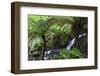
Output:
[{"xmin": 28, "ymin": 15, "xmax": 88, "ymax": 60}]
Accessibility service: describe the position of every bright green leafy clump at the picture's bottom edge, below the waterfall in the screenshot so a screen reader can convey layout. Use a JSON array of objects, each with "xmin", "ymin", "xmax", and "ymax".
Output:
[{"xmin": 52, "ymin": 48, "xmax": 82, "ymax": 59}]
